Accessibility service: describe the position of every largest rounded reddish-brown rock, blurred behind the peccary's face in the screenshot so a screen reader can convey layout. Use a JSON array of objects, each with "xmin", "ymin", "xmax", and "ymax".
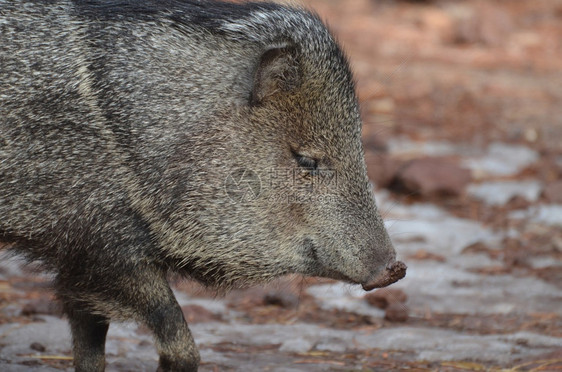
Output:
[{"xmin": 391, "ymin": 158, "xmax": 471, "ymax": 196}]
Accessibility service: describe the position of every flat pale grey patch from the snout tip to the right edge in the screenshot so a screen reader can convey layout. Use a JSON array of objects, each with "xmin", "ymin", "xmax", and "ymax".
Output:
[{"xmin": 388, "ymin": 260, "xmax": 562, "ymax": 316}]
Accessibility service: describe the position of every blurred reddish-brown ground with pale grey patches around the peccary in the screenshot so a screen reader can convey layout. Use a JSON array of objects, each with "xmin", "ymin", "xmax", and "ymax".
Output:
[{"xmin": 0, "ymin": 0, "xmax": 562, "ymax": 371}]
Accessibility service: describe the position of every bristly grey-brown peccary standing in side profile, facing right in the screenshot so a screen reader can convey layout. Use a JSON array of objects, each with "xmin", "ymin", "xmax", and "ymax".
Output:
[{"xmin": 0, "ymin": 0, "xmax": 405, "ymax": 371}]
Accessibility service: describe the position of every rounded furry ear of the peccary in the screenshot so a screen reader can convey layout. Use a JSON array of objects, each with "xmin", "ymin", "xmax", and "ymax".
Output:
[{"xmin": 250, "ymin": 45, "xmax": 302, "ymax": 106}]
